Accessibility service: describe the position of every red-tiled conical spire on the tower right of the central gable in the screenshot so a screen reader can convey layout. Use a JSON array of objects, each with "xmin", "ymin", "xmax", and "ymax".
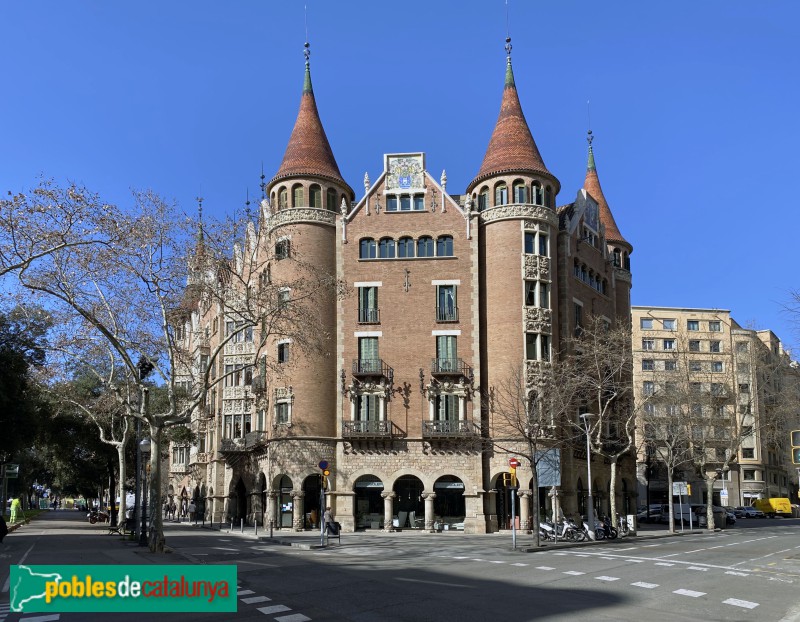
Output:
[{"xmin": 468, "ymin": 37, "xmax": 559, "ymax": 192}]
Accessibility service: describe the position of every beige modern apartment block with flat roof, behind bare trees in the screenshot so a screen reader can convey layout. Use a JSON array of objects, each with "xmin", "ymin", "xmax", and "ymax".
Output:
[{"xmin": 631, "ymin": 306, "xmax": 797, "ymax": 506}]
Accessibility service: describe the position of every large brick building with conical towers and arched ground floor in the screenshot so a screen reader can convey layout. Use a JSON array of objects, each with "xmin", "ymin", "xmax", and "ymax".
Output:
[{"xmin": 169, "ymin": 40, "xmax": 635, "ymax": 533}]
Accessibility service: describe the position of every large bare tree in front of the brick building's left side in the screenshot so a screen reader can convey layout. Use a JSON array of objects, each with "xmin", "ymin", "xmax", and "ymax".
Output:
[{"xmin": 8, "ymin": 184, "xmax": 337, "ymax": 551}]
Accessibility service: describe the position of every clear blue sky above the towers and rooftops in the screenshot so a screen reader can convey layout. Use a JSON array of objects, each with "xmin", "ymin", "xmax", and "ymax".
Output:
[{"xmin": 0, "ymin": 0, "xmax": 800, "ymax": 356}]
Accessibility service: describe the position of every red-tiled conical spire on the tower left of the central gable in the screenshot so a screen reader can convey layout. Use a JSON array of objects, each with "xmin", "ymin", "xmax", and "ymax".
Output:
[{"xmin": 268, "ymin": 43, "xmax": 354, "ymax": 195}]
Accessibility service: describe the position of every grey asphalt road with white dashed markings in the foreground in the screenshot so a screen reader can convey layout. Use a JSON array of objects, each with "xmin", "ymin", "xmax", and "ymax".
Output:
[{"xmin": 0, "ymin": 511, "xmax": 800, "ymax": 622}]
